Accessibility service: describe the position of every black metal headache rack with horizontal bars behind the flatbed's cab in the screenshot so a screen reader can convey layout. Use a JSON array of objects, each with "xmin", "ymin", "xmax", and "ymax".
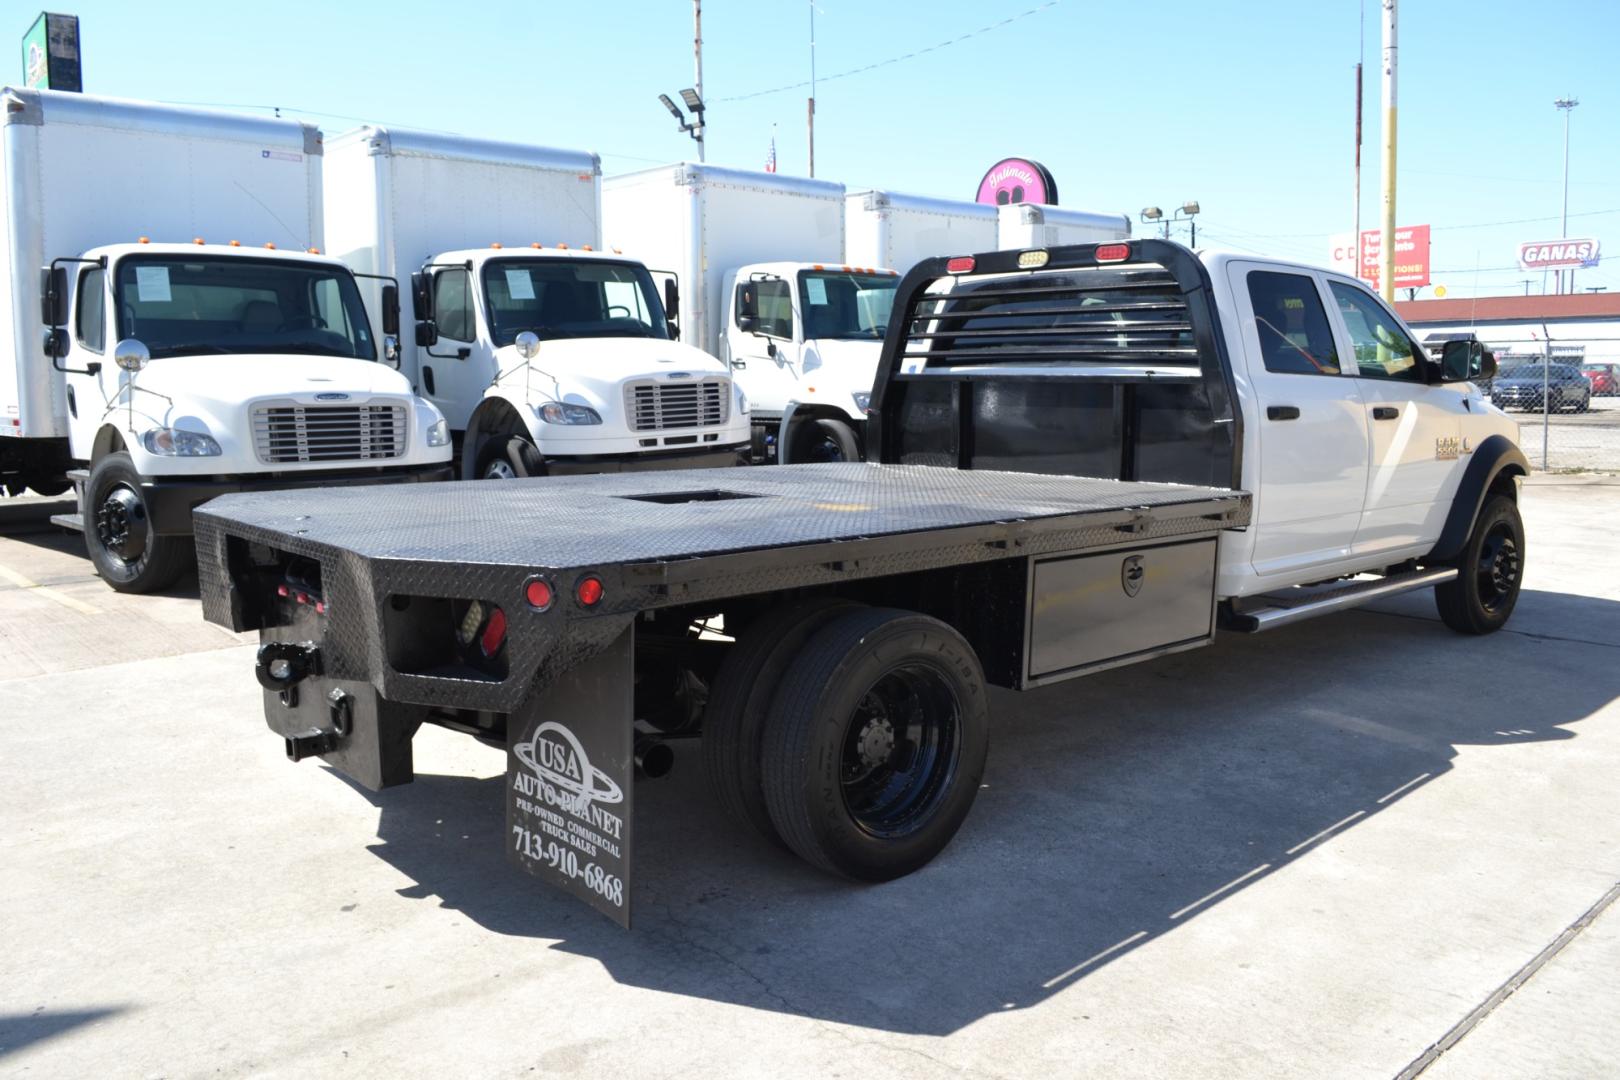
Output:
[{"xmin": 867, "ymin": 240, "xmax": 1243, "ymax": 489}]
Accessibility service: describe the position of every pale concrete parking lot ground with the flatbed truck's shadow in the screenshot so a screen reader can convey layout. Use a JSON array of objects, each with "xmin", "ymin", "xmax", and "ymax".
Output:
[{"xmin": 0, "ymin": 476, "xmax": 1620, "ymax": 1080}]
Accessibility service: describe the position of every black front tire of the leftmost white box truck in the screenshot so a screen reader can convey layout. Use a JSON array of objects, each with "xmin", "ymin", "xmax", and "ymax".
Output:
[{"xmin": 83, "ymin": 450, "xmax": 194, "ymax": 593}]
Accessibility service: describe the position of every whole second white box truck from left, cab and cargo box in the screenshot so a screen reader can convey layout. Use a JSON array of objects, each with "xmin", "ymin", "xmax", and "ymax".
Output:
[{"xmin": 326, "ymin": 126, "xmax": 748, "ymax": 479}]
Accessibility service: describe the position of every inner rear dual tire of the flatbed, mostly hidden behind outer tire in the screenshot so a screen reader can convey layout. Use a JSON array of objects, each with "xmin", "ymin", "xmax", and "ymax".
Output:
[{"xmin": 701, "ymin": 596, "xmax": 859, "ymax": 845}]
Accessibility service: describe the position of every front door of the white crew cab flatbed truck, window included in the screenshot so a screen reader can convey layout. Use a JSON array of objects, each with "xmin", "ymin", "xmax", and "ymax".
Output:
[{"xmin": 1327, "ymin": 277, "xmax": 1466, "ymax": 554}]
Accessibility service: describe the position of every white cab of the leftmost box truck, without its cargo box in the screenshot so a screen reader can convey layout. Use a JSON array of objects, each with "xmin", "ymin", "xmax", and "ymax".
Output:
[{"xmin": 41, "ymin": 241, "xmax": 450, "ymax": 593}]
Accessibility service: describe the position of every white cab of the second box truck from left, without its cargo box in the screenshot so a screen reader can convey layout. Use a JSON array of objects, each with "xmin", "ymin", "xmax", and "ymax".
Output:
[{"xmin": 411, "ymin": 244, "xmax": 750, "ymax": 479}]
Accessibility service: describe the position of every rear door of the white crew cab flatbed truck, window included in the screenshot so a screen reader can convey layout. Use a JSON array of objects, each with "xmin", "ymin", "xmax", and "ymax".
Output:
[{"xmin": 1228, "ymin": 262, "xmax": 1367, "ymax": 575}]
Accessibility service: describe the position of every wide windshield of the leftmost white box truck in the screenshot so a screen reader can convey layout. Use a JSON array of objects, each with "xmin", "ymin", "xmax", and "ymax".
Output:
[{"xmin": 117, "ymin": 256, "xmax": 376, "ymax": 359}]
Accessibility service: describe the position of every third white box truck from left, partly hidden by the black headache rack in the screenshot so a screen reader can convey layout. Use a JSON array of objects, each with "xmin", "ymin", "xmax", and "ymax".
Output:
[{"xmin": 603, "ymin": 162, "xmax": 899, "ymax": 461}]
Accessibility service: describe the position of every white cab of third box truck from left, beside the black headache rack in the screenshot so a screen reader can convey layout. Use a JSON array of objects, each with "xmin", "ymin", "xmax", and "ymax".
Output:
[{"xmin": 719, "ymin": 262, "xmax": 899, "ymax": 461}]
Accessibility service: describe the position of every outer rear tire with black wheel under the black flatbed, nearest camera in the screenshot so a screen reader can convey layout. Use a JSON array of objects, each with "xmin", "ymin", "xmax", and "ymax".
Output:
[{"xmin": 765, "ymin": 609, "xmax": 990, "ymax": 881}]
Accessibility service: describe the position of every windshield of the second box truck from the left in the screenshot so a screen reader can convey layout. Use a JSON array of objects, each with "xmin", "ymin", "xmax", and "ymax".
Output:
[{"xmin": 484, "ymin": 257, "xmax": 669, "ymax": 347}]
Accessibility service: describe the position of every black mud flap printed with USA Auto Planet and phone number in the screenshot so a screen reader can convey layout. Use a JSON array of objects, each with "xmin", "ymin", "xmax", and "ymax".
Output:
[{"xmin": 507, "ymin": 625, "xmax": 635, "ymax": 928}]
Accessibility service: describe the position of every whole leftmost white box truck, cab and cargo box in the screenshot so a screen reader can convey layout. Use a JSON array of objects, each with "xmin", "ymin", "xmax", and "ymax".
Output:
[{"xmin": 0, "ymin": 89, "xmax": 450, "ymax": 593}]
